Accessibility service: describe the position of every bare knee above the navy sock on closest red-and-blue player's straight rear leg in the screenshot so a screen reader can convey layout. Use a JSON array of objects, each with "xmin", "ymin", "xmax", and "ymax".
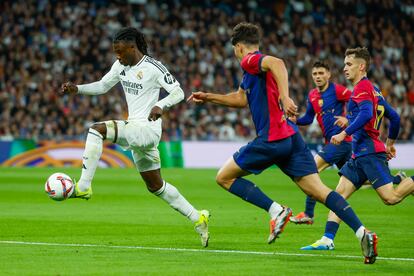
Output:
[{"xmin": 295, "ymin": 173, "xmax": 332, "ymax": 202}]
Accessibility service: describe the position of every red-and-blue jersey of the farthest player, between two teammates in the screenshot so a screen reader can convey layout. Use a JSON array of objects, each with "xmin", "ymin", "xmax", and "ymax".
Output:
[{"xmin": 296, "ymin": 82, "xmax": 352, "ymax": 143}]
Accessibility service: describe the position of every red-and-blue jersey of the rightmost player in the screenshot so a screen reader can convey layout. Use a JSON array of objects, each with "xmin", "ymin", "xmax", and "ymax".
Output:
[{"xmin": 348, "ymin": 78, "xmax": 385, "ymax": 158}]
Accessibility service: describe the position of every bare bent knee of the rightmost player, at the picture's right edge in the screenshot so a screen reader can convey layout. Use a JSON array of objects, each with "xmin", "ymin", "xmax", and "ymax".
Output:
[{"xmin": 376, "ymin": 177, "xmax": 414, "ymax": 205}]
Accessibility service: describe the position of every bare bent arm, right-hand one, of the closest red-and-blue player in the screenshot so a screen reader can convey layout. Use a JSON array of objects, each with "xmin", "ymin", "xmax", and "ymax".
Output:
[{"xmin": 261, "ymin": 56, "xmax": 298, "ymax": 116}]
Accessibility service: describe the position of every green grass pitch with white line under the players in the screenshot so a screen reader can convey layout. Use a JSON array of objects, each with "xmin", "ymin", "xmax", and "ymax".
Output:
[{"xmin": 0, "ymin": 168, "xmax": 414, "ymax": 275}]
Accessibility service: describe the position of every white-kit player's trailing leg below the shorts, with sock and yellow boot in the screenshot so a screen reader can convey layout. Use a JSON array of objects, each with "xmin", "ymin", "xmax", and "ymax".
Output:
[{"xmin": 140, "ymin": 169, "xmax": 210, "ymax": 247}]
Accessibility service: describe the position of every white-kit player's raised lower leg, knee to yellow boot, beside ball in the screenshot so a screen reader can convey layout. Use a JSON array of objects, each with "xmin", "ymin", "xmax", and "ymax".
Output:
[{"xmin": 72, "ymin": 123, "xmax": 106, "ymax": 199}]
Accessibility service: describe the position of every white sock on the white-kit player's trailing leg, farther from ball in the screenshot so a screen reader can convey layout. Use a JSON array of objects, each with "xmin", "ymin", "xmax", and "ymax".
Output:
[{"xmin": 154, "ymin": 181, "xmax": 200, "ymax": 222}]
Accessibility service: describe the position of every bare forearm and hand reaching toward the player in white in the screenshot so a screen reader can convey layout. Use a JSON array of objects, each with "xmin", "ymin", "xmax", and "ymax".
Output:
[{"xmin": 187, "ymin": 87, "xmax": 247, "ymax": 108}]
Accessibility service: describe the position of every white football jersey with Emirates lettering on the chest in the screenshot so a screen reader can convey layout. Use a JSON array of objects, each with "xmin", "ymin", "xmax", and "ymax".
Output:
[{"xmin": 101, "ymin": 55, "xmax": 180, "ymax": 121}]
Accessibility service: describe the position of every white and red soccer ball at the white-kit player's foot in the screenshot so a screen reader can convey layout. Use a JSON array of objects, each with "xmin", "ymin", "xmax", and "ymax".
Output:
[{"xmin": 45, "ymin": 173, "xmax": 75, "ymax": 201}]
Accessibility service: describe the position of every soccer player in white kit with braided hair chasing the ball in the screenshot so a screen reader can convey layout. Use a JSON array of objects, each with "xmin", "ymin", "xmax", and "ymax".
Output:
[{"xmin": 62, "ymin": 27, "xmax": 209, "ymax": 247}]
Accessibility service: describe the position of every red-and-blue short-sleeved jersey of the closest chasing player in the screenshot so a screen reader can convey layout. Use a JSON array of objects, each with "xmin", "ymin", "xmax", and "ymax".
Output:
[{"xmin": 240, "ymin": 51, "xmax": 297, "ymax": 141}]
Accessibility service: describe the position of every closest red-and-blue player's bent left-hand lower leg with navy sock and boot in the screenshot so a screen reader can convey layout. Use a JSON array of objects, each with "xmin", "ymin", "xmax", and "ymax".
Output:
[{"xmin": 216, "ymin": 157, "xmax": 292, "ymax": 243}]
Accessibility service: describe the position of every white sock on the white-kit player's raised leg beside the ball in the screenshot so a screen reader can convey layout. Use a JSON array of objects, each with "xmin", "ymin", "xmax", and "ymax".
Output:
[{"xmin": 78, "ymin": 128, "xmax": 103, "ymax": 192}]
